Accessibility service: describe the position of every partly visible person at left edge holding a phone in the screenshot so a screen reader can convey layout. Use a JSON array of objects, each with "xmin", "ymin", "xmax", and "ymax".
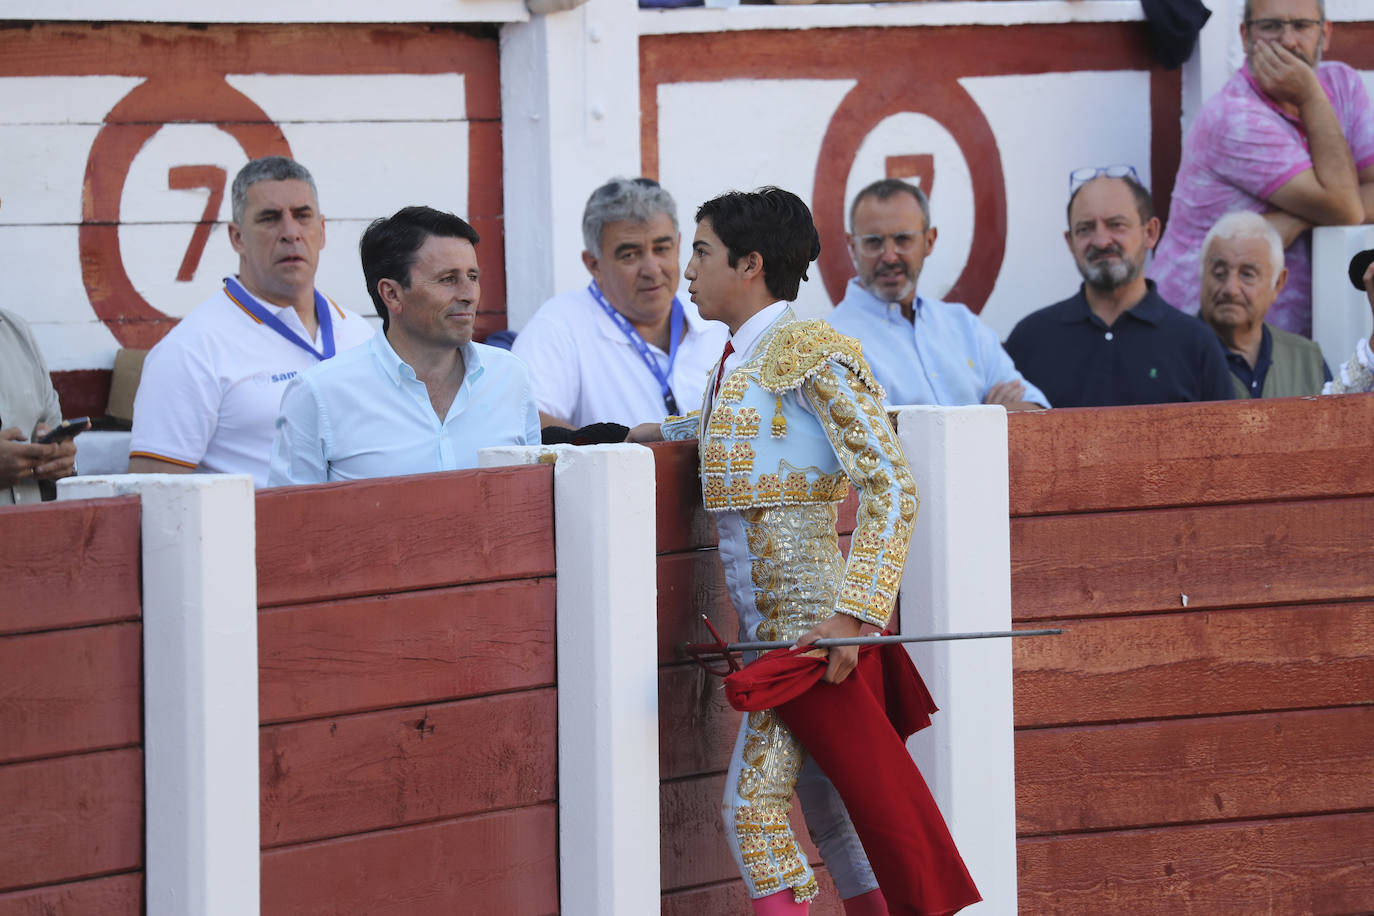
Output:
[{"xmin": 0, "ymin": 309, "xmax": 77, "ymax": 505}]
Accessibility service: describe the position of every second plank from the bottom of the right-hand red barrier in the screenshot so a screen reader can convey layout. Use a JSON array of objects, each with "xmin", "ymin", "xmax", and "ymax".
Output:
[{"xmin": 1015, "ymin": 706, "xmax": 1374, "ymax": 836}]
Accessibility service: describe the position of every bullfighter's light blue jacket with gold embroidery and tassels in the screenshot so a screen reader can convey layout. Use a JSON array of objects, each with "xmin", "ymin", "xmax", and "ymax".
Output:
[{"xmin": 664, "ymin": 309, "xmax": 918, "ymax": 626}]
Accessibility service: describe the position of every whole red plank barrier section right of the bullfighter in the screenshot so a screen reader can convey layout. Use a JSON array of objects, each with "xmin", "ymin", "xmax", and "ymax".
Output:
[{"xmin": 1010, "ymin": 396, "xmax": 1374, "ymax": 916}]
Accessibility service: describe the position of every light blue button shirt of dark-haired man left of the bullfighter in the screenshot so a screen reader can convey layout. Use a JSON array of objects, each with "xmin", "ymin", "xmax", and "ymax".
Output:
[{"xmin": 268, "ymin": 331, "xmax": 540, "ymax": 486}]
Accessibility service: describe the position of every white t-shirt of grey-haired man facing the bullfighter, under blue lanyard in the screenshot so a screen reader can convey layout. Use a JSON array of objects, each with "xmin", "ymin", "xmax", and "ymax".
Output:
[{"xmin": 511, "ymin": 287, "xmax": 730, "ymax": 427}]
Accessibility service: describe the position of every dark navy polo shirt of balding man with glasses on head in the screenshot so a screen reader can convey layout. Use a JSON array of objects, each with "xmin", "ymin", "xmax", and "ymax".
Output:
[{"xmin": 1006, "ymin": 280, "xmax": 1234, "ymax": 407}]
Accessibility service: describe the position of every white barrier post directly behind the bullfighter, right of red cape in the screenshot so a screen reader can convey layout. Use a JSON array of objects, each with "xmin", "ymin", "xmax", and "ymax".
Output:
[{"xmin": 897, "ymin": 405, "xmax": 1017, "ymax": 915}]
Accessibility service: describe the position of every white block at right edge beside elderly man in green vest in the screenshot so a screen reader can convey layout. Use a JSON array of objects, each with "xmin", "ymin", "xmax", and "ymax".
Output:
[{"xmin": 1312, "ymin": 225, "xmax": 1374, "ymax": 375}]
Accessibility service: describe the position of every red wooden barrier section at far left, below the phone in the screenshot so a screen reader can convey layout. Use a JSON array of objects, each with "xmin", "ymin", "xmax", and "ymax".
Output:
[{"xmin": 0, "ymin": 497, "xmax": 143, "ymax": 916}]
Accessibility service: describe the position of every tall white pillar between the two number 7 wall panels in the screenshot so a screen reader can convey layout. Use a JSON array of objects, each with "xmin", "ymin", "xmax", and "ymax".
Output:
[{"xmin": 502, "ymin": 0, "xmax": 640, "ymax": 330}]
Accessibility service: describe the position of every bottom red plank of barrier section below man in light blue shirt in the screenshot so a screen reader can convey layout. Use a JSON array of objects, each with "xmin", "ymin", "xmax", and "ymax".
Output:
[{"xmin": 262, "ymin": 805, "xmax": 558, "ymax": 916}]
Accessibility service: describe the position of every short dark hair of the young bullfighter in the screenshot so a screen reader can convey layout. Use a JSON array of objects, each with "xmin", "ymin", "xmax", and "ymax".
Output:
[{"xmin": 697, "ymin": 185, "xmax": 820, "ymax": 302}]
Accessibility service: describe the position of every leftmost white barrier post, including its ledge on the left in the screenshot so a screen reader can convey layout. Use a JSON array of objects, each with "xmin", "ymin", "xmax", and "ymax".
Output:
[{"xmin": 58, "ymin": 474, "xmax": 260, "ymax": 916}]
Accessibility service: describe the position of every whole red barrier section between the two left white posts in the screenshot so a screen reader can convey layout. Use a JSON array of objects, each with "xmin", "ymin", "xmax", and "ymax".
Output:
[{"xmin": 257, "ymin": 466, "xmax": 558, "ymax": 916}]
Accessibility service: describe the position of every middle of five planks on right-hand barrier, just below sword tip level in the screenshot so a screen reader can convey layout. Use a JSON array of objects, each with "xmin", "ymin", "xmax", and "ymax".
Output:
[{"xmin": 1013, "ymin": 603, "xmax": 1374, "ymax": 726}]
